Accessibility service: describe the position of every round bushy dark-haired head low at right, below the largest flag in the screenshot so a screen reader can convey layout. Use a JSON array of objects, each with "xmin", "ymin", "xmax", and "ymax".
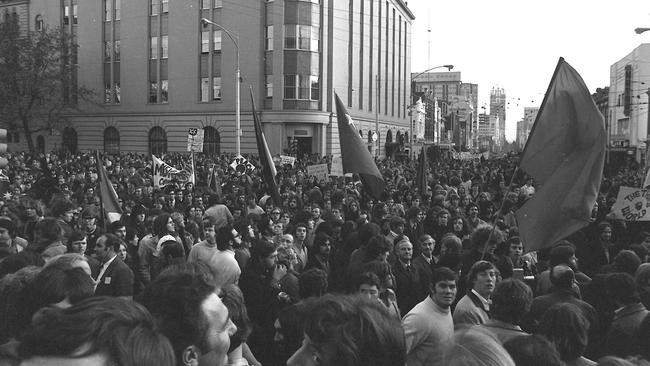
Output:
[{"xmin": 537, "ymin": 303, "xmax": 589, "ymax": 362}]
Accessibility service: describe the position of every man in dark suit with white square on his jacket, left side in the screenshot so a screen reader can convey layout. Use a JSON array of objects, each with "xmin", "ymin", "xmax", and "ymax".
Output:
[{"xmin": 94, "ymin": 234, "xmax": 133, "ymax": 299}]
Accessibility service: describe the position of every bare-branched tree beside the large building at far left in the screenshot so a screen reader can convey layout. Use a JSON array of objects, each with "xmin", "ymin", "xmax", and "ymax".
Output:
[{"xmin": 0, "ymin": 17, "xmax": 93, "ymax": 154}]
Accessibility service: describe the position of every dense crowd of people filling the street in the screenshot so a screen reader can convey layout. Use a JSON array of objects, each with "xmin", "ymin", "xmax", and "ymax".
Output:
[{"xmin": 0, "ymin": 152, "xmax": 650, "ymax": 366}]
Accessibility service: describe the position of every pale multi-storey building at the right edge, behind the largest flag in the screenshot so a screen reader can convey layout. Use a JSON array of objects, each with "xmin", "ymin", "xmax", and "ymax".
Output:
[{"xmin": 607, "ymin": 43, "xmax": 650, "ymax": 166}]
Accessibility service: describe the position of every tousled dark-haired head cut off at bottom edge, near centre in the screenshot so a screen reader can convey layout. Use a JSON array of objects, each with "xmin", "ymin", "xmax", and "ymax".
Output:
[{"xmin": 304, "ymin": 294, "xmax": 406, "ymax": 366}]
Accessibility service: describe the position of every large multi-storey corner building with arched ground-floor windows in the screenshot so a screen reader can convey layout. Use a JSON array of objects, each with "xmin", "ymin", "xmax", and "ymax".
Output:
[{"xmin": 2, "ymin": 0, "xmax": 414, "ymax": 155}]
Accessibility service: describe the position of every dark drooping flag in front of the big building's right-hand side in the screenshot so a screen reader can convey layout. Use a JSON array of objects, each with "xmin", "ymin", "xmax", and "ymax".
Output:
[{"xmin": 334, "ymin": 93, "xmax": 386, "ymax": 200}]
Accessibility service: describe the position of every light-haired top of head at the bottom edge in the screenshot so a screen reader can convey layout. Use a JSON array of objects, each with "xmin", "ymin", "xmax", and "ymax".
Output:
[{"xmin": 425, "ymin": 327, "xmax": 515, "ymax": 366}]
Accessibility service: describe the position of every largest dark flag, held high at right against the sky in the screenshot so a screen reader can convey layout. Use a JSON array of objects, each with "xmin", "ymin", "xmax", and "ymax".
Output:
[{"xmin": 516, "ymin": 58, "xmax": 606, "ymax": 251}]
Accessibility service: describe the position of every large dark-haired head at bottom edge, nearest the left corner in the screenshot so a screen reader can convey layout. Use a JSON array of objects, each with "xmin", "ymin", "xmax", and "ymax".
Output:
[{"xmin": 18, "ymin": 296, "xmax": 175, "ymax": 366}]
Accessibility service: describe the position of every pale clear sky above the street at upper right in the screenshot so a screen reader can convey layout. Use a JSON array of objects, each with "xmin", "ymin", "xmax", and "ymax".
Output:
[{"xmin": 408, "ymin": 0, "xmax": 650, "ymax": 141}]
